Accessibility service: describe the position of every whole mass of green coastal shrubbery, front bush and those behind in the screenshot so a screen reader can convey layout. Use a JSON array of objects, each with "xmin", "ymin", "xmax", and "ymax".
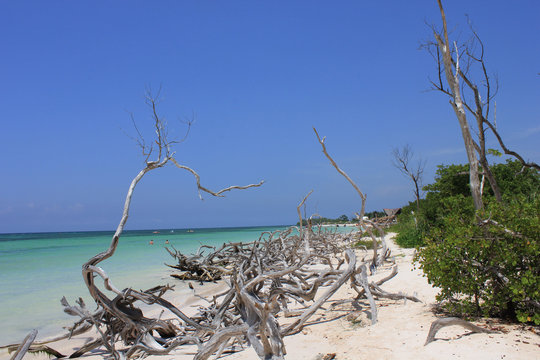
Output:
[{"xmin": 394, "ymin": 160, "xmax": 540, "ymax": 325}]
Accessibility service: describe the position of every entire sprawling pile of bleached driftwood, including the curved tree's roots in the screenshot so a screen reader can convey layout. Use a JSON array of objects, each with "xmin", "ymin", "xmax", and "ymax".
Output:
[{"xmin": 5, "ymin": 224, "xmax": 417, "ymax": 359}]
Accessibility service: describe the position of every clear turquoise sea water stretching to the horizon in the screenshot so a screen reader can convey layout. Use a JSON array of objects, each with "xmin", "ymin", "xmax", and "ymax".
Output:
[{"xmin": 0, "ymin": 226, "xmax": 284, "ymax": 345}]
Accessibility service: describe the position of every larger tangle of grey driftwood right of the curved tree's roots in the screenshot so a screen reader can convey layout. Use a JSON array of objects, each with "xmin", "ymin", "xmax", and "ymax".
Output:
[{"xmin": 157, "ymin": 221, "xmax": 395, "ymax": 359}]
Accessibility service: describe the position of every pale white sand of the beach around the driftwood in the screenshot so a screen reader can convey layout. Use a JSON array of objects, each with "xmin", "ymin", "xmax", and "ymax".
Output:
[{"xmin": 0, "ymin": 236, "xmax": 540, "ymax": 360}]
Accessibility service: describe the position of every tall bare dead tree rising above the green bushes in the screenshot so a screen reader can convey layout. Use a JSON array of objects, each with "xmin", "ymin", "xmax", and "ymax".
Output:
[{"xmin": 424, "ymin": 0, "xmax": 540, "ymax": 209}]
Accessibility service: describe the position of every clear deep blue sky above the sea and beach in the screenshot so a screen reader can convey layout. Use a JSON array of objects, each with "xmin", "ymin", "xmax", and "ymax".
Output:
[{"xmin": 0, "ymin": 0, "xmax": 540, "ymax": 233}]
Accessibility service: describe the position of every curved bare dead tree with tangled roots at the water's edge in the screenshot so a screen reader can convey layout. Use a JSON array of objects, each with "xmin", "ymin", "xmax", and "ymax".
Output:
[{"xmin": 75, "ymin": 93, "xmax": 263, "ymax": 359}]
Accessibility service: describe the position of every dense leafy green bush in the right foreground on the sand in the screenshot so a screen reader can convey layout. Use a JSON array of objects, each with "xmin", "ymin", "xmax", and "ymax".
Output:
[{"xmin": 417, "ymin": 192, "xmax": 540, "ymax": 325}]
